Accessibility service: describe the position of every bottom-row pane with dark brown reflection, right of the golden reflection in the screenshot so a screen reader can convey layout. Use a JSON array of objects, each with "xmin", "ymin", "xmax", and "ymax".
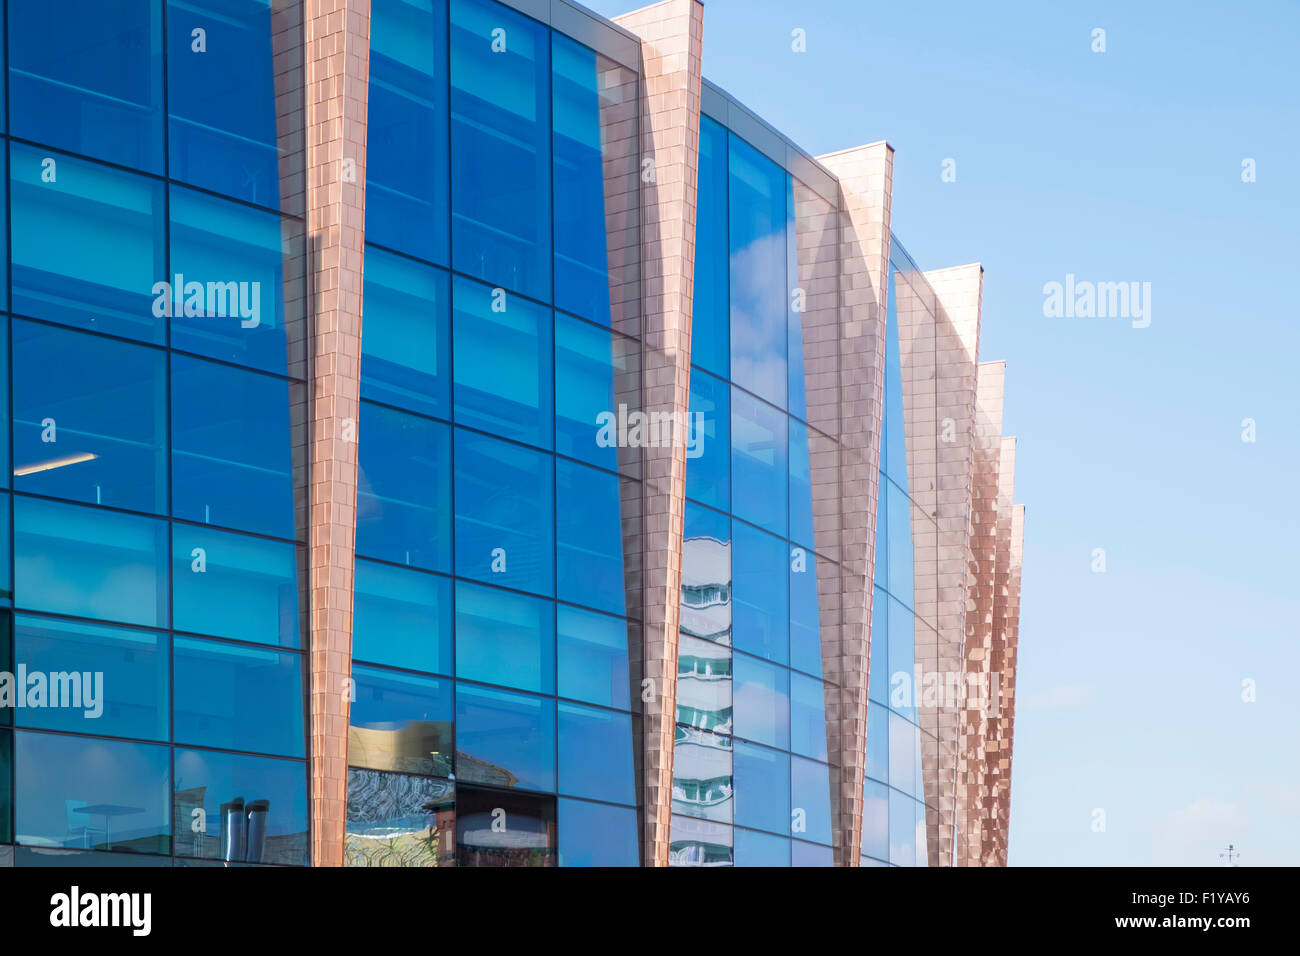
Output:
[{"xmin": 456, "ymin": 786, "xmax": 556, "ymax": 866}]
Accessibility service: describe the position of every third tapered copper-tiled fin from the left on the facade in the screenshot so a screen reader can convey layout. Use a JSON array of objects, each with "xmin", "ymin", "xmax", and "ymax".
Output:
[{"xmin": 806, "ymin": 142, "xmax": 893, "ymax": 866}]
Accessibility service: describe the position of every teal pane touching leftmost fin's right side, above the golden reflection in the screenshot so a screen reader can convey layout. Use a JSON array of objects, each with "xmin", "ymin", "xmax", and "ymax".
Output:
[{"xmin": 352, "ymin": 558, "xmax": 451, "ymax": 674}]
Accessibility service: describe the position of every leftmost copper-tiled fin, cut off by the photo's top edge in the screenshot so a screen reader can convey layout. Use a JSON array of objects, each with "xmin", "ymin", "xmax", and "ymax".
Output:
[{"xmin": 306, "ymin": 0, "xmax": 371, "ymax": 866}]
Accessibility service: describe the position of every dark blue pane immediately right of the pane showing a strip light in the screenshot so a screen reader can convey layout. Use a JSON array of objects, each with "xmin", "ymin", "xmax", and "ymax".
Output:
[{"xmin": 172, "ymin": 355, "xmax": 302, "ymax": 538}]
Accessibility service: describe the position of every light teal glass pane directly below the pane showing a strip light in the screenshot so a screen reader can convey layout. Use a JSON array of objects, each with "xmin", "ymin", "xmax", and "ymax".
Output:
[{"xmin": 13, "ymin": 497, "xmax": 168, "ymax": 627}]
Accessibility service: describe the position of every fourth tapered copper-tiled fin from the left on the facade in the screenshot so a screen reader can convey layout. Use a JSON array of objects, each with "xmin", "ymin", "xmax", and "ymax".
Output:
[{"xmin": 894, "ymin": 263, "xmax": 984, "ymax": 866}]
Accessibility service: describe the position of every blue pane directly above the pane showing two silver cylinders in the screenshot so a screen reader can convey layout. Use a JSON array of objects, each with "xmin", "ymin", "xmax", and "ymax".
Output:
[{"xmin": 173, "ymin": 637, "xmax": 306, "ymax": 757}]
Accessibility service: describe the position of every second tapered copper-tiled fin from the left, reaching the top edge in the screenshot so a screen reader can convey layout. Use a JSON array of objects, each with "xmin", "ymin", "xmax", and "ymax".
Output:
[{"xmin": 615, "ymin": 0, "xmax": 705, "ymax": 866}]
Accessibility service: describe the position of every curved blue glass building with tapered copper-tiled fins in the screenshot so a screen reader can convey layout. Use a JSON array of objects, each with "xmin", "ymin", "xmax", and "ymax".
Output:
[{"xmin": 0, "ymin": 0, "xmax": 1023, "ymax": 866}]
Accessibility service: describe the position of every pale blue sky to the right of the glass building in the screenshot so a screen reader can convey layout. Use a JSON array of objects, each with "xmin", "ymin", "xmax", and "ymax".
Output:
[{"xmin": 588, "ymin": 0, "xmax": 1300, "ymax": 866}]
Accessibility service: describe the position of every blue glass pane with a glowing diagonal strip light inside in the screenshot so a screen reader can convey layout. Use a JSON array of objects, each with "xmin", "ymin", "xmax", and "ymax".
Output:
[{"xmin": 13, "ymin": 320, "xmax": 166, "ymax": 512}]
